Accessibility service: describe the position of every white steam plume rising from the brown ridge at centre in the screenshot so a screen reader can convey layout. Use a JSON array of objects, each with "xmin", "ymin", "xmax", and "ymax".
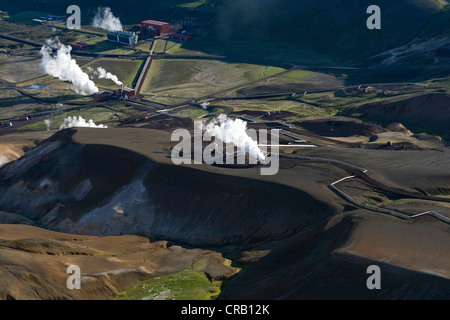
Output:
[{"xmin": 203, "ymin": 114, "xmax": 265, "ymax": 160}]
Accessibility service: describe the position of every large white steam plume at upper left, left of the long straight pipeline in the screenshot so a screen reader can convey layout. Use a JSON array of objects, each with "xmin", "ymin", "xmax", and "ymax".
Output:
[{"xmin": 39, "ymin": 39, "xmax": 98, "ymax": 94}]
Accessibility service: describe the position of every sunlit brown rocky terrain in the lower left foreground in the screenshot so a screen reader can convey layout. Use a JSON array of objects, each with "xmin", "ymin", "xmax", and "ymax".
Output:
[{"xmin": 0, "ymin": 224, "xmax": 239, "ymax": 300}]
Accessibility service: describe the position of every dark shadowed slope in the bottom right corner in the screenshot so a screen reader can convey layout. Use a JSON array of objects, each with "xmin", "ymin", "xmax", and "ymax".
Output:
[{"xmin": 224, "ymin": 217, "xmax": 450, "ymax": 300}]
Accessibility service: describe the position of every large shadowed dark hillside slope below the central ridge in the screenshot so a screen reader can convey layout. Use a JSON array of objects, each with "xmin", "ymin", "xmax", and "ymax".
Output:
[{"xmin": 0, "ymin": 130, "xmax": 336, "ymax": 246}]
